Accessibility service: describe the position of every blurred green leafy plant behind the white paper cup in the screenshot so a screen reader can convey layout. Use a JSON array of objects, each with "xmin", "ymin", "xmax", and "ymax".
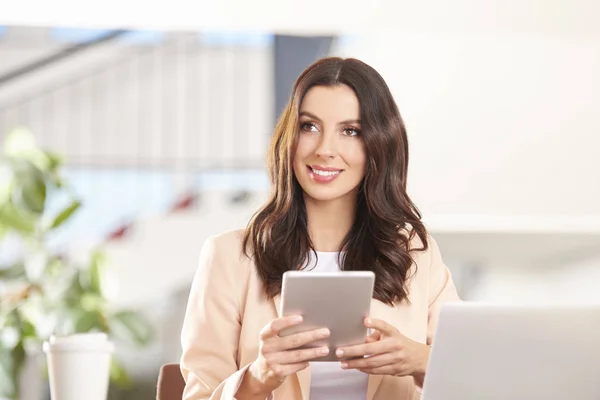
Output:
[{"xmin": 0, "ymin": 129, "xmax": 152, "ymax": 399}]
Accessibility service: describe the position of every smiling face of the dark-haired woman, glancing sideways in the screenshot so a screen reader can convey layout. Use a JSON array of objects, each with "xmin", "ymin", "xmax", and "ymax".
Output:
[{"xmin": 294, "ymin": 85, "xmax": 366, "ymax": 201}]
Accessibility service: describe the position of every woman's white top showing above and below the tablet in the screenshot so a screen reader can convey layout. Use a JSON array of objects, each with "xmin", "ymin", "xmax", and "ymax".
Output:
[{"xmin": 306, "ymin": 252, "xmax": 369, "ymax": 400}]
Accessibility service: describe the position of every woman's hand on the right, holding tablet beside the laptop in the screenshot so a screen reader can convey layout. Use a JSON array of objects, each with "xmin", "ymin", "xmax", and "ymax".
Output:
[{"xmin": 336, "ymin": 318, "xmax": 430, "ymax": 382}]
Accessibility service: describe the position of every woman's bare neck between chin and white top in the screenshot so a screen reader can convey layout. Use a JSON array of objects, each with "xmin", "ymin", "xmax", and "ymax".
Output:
[{"xmin": 304, "ymin": 193, "xmax": 356, "ymax": 252}]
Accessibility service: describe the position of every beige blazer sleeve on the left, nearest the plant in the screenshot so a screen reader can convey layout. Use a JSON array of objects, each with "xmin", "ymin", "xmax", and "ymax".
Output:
[{"xmin": 180, "ymin": 236, "xmax": 247, "ymax": 400}]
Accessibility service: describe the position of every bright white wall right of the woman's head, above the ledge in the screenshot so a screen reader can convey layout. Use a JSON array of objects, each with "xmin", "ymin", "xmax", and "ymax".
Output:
[{"xmin": 338, "ymin": 33, "xmax": 600, "ymax": 216}]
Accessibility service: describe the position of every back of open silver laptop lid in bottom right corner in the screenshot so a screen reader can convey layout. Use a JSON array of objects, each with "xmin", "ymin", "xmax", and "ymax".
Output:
[{"xmin": 422, "ymin": 303, "xmax": 600, "ymax": 400}]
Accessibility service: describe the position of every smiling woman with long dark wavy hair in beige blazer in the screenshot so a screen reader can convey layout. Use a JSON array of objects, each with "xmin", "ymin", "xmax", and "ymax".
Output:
[{"xmin": 181, "ymin": 58, "xmax": 458, "ymax": 400}]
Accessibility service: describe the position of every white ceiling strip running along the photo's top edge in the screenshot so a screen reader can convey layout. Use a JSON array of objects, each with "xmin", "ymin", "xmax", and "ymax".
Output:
[{"xmin": 0, "ymin": 0, "xmax": 600, "ymax": 34}]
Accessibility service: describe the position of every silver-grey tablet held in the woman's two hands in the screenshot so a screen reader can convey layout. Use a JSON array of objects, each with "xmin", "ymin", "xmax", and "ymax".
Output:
[{"xmin": 280, "ymin": 271, "xmax": 375, "ymax": 361}]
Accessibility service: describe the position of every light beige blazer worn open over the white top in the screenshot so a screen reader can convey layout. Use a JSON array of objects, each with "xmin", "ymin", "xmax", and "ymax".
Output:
[{"xmin": 180, "ymin": 231, "xmax": 458, "ymax": 400}]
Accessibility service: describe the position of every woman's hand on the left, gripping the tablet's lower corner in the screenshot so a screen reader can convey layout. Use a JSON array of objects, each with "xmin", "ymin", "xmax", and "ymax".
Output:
[{"xmin": 243, "ymin": 315, "xmax": 330, "ymax": 397}]
